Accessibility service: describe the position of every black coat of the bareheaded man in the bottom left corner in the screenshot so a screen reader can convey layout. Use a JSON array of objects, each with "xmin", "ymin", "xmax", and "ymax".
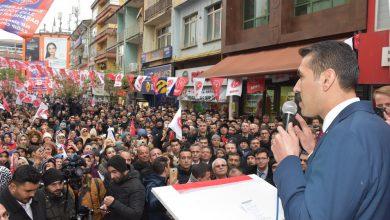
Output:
[{"xmin": 0, "ymin": 188, "xmax": 46, "ymax": 220}]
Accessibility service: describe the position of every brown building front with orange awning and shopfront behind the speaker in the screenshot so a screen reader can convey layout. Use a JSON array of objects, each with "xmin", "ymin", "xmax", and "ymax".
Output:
[{"xmin": 202, "ymin": 0, "xmax": 367, "ymax": 117}]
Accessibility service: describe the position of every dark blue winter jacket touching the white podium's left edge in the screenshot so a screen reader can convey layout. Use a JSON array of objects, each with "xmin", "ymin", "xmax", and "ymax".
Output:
[{"xmin": 144, "ymin": 173, "xmax": 169, "ymax": 220}]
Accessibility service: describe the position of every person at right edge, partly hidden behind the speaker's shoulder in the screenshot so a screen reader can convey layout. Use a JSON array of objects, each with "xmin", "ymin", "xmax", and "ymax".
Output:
[{"xmin": 374, "ymin": 86, "xmax": 390, "ymax": 125}]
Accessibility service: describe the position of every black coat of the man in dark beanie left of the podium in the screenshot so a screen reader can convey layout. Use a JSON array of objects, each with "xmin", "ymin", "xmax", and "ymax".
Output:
[{"xmin": 104, "ymin": 170, "xmax": 145, "ymax": 220}]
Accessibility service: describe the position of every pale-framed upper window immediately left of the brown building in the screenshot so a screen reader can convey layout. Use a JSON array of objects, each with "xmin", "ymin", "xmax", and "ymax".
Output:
[{"xmin": 207, "ymin": 3, "xmax": 221, "ymax": 41}]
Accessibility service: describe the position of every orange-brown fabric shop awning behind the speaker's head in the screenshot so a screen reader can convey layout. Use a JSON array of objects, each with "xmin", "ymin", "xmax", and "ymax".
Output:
[{"xmin": 199, "ymin": 45, "xmax": 307, "ymax": 78}]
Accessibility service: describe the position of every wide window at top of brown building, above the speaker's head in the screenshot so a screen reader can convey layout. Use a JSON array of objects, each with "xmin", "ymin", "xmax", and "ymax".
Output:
[{"xmin": 294, "ymin": 0, "xmax": 349, "ymax": 16}]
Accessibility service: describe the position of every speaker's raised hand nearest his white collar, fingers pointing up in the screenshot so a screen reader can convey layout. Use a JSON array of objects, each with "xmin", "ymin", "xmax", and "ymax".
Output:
[{"xmin": 294, "ymin": 114, "xmax": 316, "ymax": 154}]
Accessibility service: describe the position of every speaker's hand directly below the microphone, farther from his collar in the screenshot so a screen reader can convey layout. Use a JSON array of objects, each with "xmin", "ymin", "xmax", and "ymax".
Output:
[{"xmin": 271, "ymin": 123, "xmax": 300, "ymax": 163}]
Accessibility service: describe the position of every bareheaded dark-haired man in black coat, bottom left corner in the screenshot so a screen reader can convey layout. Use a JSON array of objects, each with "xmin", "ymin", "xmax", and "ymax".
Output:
[{"xmin": 0, "ymin": 165, "xmax": 46, "ymax": 220}]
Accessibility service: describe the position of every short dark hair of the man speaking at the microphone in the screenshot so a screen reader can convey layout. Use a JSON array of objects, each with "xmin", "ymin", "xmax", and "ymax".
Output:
[{"xmin": 299, "ymin": 40, "xmax": 359, "ymax": 90}]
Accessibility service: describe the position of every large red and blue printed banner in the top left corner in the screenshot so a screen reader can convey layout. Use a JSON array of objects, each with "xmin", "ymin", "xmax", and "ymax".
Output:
[{"xmin": 0, "ymin": 0, "xmax": 53, "ymax": 38}]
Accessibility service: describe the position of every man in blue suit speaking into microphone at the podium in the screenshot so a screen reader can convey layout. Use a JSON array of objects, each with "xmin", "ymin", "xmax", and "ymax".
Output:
[{"xmin": 272, "ymin": 41, "xmax": 390, "ymax": 220}]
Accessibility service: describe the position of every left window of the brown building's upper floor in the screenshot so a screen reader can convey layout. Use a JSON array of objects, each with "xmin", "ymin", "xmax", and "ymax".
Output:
[{"xmin": 244, "ymin": 0, "xmax": 269, "ymax": 29}]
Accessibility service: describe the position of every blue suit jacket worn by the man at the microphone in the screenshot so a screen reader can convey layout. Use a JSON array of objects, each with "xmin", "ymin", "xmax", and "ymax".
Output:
[{"xmin": 274, "ymin": 101, "xmax": 390, "ymax": 220}]
